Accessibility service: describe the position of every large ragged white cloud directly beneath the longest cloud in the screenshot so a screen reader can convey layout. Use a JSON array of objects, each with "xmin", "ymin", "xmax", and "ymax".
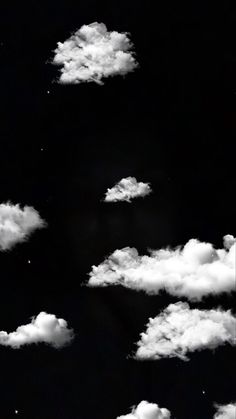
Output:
[{"xmin": 136, "ymin": 302, "xmax": 236, "ymax": 361}]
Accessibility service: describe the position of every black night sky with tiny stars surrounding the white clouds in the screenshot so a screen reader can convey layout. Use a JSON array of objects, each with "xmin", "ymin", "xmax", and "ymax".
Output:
[{"xmin": 0, "ymin": 0, "xmax": 236, "ymax": 419}]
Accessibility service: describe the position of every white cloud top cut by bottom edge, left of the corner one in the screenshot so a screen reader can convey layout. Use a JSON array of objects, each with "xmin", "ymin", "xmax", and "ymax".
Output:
[{"xmin": 117, "ymin": 401, "xmax": 170, "ymax": 419}]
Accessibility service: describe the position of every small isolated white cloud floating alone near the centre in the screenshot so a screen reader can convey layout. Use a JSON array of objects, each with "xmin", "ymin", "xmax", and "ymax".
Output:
[{"xmin": 104, "ymin": 177, "xmax": 152, "ymax": 202}]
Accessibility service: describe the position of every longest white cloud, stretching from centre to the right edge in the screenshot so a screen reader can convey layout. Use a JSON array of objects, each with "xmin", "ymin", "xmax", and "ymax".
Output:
[{"xmin": 88, "ymin": 234, "xmax": 236, "ymax": 300}]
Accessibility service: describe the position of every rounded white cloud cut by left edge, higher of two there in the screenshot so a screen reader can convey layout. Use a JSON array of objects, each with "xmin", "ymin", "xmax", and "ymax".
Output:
[{"xmin": 0, "ymin": 203, "xmax": 46, "ymax": 250}]
